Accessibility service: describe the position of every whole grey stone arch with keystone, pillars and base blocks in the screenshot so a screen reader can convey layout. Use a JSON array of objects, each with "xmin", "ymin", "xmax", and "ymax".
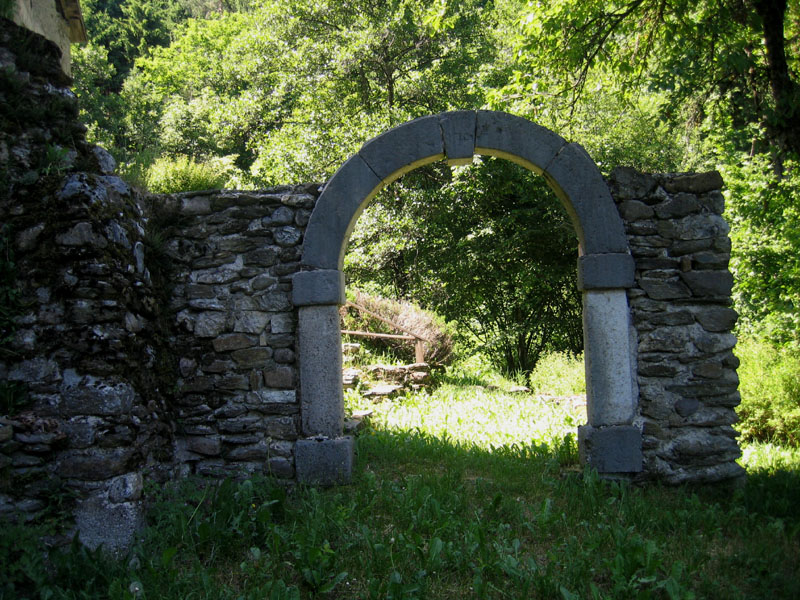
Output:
[{"xmin": 292, "ymin": 111, "xmax": 642, "ymax": 483}]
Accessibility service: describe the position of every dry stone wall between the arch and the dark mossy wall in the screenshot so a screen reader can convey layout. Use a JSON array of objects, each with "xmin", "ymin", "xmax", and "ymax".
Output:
[{"xmin": 155, "ymin": 185, "xmax": 319, "ymax": 478}]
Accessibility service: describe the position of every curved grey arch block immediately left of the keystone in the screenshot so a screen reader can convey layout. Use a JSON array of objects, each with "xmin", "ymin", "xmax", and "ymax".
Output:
[{"xmin": 358, "ymin": 116, "xmax": 444, "ymax": 184}]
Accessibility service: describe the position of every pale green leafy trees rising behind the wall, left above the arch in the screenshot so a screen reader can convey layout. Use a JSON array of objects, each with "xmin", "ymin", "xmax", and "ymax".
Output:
[{"xmin": 115, "ymin": 0, "xmax": 492, "ymax": 184}]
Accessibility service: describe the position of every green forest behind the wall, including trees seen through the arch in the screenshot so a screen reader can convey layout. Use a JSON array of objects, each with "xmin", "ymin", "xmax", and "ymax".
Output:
[{"xmin": 73, "ymin": 0, "xmax": 800, "ymax": 445}]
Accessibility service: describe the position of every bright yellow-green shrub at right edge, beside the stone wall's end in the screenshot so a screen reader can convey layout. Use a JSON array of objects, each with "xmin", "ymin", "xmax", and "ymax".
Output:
[{"xmin": 737, "ymin": 338, "xmax": 800, "ymax": 446}]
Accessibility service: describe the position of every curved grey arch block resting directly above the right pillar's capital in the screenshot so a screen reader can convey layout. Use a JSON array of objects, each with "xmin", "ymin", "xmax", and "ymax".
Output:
[{"xmin": 544, "ymin": 144, "xmax": 628, "ymax": 254}]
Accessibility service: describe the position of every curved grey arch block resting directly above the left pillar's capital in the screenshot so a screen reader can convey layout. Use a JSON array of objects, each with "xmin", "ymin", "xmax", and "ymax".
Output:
[{"xmin": 302, "ymin": 155, "xmax": 382, "ymax": 269}]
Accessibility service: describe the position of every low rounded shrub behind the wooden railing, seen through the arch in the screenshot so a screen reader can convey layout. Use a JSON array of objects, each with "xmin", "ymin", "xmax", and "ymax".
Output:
[{"xmin": 341, "ymin": 290, "xmax": 453, "ymax": 364}]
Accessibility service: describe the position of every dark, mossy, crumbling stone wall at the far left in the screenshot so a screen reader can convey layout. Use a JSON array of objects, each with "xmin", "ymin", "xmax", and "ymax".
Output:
[{"xmin": 0, "ymin": 20, "xmax": 172, "ymax": 545}]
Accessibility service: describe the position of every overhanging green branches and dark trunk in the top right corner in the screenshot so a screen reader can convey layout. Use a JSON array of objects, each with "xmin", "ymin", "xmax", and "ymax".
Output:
[{"xmin": 506, "ymin": 0, "xmax": 800, "ymax": 161}]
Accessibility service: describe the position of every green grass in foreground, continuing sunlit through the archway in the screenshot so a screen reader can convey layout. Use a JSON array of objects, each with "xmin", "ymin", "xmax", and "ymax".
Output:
[{"xmin": 0, "ymin": 354, "xmax": 800, "ymax": 600}]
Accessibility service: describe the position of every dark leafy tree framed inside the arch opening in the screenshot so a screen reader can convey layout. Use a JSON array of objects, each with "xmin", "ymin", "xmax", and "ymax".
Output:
[{"xmin": 346, "ymin": 158, "xmax": 583, "ymax": 373}]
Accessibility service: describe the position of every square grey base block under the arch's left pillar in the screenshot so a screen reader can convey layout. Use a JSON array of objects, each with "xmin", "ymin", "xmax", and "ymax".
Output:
[{"xmin": 294, "ymin": 436, "xmax": 353, "ymax": 486}]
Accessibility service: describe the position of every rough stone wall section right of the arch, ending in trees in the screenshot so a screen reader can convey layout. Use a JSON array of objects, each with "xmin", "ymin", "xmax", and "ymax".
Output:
[{"xmin": 609, "ymin": 168, "xmax": 744, "ymax": 483}]
